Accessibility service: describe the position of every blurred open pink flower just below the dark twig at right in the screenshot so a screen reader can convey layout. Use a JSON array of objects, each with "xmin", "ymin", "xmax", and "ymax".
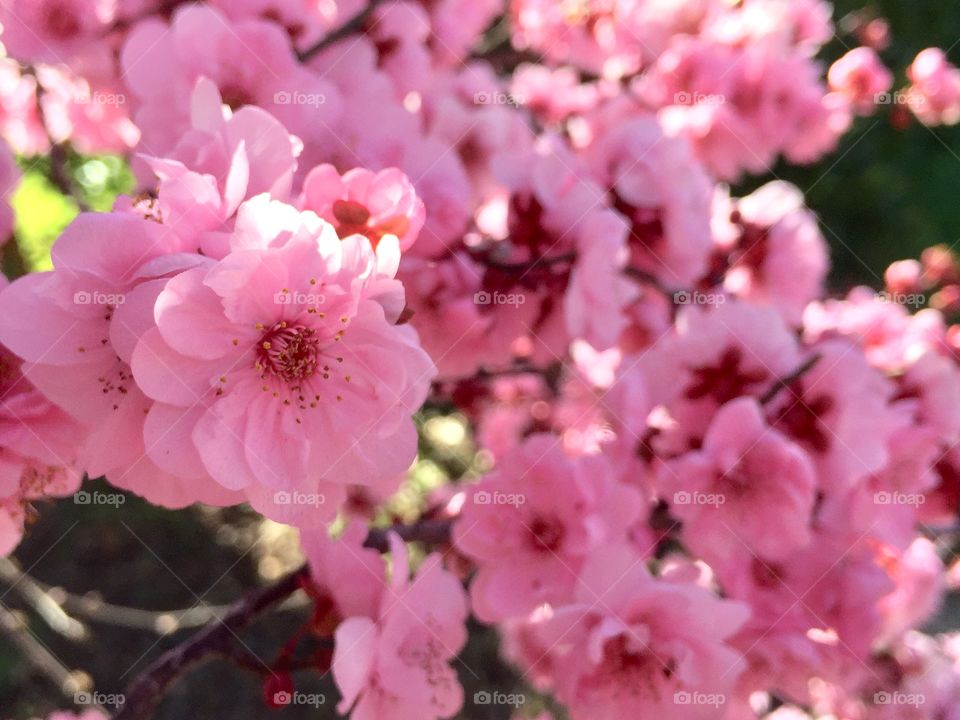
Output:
[{"xmin": 662, "ymin": 398, "xmax": 817, "ymax": 561}]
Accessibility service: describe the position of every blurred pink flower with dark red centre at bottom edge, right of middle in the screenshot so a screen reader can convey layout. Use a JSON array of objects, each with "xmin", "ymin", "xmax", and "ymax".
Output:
[{"xmin": 536, "ymin": 545, "xmax": 749, "ymax": 720}]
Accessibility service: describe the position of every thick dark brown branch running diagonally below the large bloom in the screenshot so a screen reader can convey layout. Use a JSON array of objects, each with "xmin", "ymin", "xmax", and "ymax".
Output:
[{"xmin": 113, "ymin": 520, "xmax": 451, "ymax": 720}]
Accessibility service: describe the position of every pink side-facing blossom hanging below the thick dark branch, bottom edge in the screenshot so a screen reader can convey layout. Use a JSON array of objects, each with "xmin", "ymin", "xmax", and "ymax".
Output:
[{"xmin": 308, "ymin": 532, "xmax": 467, "ymax": 720}]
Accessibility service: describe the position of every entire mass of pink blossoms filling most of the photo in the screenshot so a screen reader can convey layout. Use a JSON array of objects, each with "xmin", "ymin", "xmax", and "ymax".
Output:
[{"xmin": 0, "ymin": 0, "xmax": 960, "ymax": 720}]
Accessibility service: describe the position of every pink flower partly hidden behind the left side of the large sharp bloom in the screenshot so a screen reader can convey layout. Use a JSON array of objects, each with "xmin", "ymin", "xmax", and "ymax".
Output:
[{"xmin": 0, "ymin": 213, "xmax": 236, "ymax": 507}]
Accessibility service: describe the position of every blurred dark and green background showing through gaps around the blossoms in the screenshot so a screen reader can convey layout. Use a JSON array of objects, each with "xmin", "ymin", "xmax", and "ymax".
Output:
[{"xmin": 0, "ymin": 0, "xmax": 960, "ymax": 720}]
